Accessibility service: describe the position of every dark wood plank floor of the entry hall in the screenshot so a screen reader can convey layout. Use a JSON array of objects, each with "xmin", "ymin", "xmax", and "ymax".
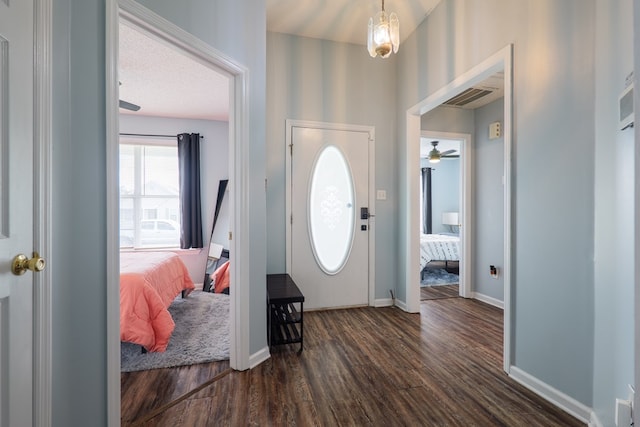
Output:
[{"xmin": 121, "ymin": 298, "xmax": 584, "ymax": 427}]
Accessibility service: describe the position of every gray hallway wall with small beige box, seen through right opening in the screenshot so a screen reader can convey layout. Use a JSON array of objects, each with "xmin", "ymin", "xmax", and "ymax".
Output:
[{"xmin": 471, "ymin": 98, "xmax": 504, "ymax": 301}]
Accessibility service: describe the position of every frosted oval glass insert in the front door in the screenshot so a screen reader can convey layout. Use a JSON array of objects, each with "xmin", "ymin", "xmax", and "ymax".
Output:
[{"xmin": 309, "ymin": 145, "xmax": 355, "ymax": 275}]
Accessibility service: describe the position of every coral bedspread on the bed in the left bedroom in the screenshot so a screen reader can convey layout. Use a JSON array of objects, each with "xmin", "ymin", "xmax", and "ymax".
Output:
[{"xmin": 120, "ymin": 252, "xmax": 194, "ymax": 351}]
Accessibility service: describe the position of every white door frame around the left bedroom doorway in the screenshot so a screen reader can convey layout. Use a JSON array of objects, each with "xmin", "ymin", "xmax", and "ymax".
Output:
[{"xmin": 106, "ymin": 0, "xmax": 250, "ymax": 426}]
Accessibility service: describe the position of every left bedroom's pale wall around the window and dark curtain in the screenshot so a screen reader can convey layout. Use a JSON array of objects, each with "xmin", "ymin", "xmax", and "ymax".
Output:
[{"xmin": 120, "ymin": 114, "xmax": 229, "ymax": 284}]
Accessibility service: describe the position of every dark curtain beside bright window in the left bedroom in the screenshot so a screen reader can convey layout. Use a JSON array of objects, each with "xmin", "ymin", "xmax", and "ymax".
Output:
[{"xmin": 178, "ymin": 133, "xmax": 204, "ymax": 249}]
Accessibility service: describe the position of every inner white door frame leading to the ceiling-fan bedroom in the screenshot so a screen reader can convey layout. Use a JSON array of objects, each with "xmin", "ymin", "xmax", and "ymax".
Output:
[{"xmin": 415, "ymin": 130, "xmax": 475, "ymax": 298}]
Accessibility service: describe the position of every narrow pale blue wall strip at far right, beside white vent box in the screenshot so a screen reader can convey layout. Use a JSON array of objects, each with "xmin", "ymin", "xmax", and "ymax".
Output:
[{"xmin": 593, "ymin": 0, "xmax": 640, "ymax": 425}]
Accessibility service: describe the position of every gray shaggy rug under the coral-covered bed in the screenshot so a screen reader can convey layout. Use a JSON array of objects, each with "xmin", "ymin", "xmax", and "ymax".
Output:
[{"xmin": 120, "ymin": 291, "xmax": 230, "ymax": 372}]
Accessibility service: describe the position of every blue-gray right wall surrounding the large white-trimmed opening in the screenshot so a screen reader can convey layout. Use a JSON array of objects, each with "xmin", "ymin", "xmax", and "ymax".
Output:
[{"xmin": 397, "ymin": 0, "xmax": 595, "ymax": 405}]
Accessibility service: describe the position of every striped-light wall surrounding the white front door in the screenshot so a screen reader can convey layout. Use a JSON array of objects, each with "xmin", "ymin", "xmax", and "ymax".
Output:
[{"xmin": 266, "ymin": 33, "xmax": 398, "ymax": 298}]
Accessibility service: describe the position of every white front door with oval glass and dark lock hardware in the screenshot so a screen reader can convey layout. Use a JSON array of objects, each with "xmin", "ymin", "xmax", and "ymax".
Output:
[{"xmin": 288, "ymin": 126, "xmax": 371, "ymax": 309}]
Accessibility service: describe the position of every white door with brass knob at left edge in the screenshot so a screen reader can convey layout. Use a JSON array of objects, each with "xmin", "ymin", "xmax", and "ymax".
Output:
[{"xmin": 0, "ymin": 0, "xmax": 36, "ymax": 426}]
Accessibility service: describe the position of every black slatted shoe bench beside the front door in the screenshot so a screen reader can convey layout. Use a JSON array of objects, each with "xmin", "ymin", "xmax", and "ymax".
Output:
[{"xmin": 267, "ymin": 274, "xmax": 304, "ymax": 353}]
